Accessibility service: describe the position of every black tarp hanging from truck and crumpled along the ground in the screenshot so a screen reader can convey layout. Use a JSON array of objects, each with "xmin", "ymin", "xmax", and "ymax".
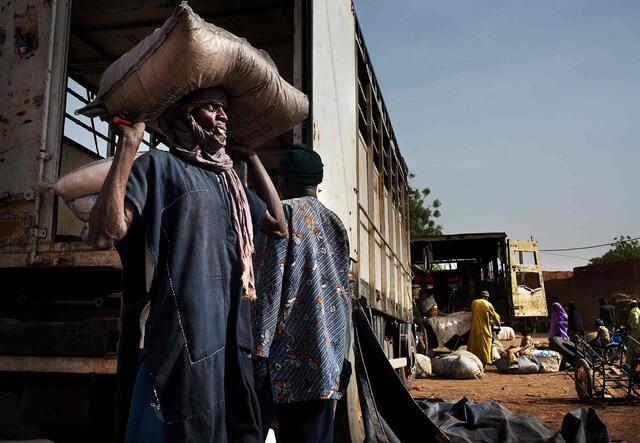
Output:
[{"xmin": 353, "ymin": 307, "xmax": 611, "ymax": 443}]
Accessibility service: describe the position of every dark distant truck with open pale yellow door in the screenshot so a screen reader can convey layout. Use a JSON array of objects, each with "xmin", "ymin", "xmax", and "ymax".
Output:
[{"xmin": 411, "ymin": 232, "xmax": 547, "ymax": 329}]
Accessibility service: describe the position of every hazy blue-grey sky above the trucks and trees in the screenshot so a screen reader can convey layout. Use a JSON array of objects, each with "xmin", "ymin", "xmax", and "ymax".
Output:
[{"xmin": 355, "ymin": 0, "xmax": 640, "ymax": 270}]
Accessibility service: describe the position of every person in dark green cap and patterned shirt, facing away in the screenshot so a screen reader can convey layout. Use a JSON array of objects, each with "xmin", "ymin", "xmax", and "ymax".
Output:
[{"xmin": 252, "ymin": 145, "xmax": 351, "ymax": 443}]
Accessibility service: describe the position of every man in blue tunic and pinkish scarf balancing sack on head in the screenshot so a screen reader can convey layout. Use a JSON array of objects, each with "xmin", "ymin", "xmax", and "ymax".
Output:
[{"xmin": 89, "ymin": 88, "xmax": 286, "ymax": 442}]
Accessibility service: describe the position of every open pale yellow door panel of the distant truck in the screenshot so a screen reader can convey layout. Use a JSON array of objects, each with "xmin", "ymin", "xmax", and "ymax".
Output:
[{"xmin": 508, "ymin": 240, "xmax": 548, "ymax": 317}]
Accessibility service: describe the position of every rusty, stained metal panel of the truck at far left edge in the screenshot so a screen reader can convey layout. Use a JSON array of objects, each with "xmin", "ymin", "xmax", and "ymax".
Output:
[{"xmin": 0, "ymin": 0, "xmax": 70, "ymax": 266}]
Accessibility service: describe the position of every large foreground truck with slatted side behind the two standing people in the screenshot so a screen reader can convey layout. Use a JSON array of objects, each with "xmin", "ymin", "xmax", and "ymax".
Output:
[{"xmin": 0, "ymin": 0, "xmax": 415, "ymax": 441}]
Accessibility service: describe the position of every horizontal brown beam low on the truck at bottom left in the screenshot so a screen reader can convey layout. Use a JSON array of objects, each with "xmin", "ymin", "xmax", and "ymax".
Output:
[{"xmin": 0, "ymin": 355, "xmax": 117, "ymax": 374}]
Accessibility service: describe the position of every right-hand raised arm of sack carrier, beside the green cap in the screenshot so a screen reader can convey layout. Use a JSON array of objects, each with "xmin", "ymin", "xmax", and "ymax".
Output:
[{"xmin": 229, "ymin": 145, "xmax": 288, "ymax": 238}]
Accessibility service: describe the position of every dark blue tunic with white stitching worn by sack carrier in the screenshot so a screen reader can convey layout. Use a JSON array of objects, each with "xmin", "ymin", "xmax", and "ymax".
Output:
[{"xmin": 118, "ymin": 151, "xmax": 266, "ymax": 442}]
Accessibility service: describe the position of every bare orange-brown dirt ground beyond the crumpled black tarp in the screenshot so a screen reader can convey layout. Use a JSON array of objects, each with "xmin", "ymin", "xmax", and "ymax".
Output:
[{"xmin": 411, "ymin": 367, "xmax": 640, "ymax": 442}]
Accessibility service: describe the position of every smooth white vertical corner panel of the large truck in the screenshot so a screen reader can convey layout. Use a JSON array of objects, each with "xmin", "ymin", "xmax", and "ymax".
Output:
[{"xmin": 312, "ymin": 0, "xmax": 358, "ymax": 258}]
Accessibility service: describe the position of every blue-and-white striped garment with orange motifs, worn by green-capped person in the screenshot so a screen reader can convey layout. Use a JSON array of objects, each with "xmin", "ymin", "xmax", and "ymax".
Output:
[{"xmin": 251, "ymin": 197, "xmax": 351, "ymax": 403}]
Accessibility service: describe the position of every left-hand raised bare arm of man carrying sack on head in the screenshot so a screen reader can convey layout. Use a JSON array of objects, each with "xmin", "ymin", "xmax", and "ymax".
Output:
[{"xmin": 89, "ymin": 123, "xmax": 145, "ymax": 249}]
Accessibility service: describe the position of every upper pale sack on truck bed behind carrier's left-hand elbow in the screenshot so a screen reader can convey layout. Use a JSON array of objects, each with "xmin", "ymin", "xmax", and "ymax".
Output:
[{"xmin": 53, "ymin": 152, "xmax": 143, "ymax": 201}]
